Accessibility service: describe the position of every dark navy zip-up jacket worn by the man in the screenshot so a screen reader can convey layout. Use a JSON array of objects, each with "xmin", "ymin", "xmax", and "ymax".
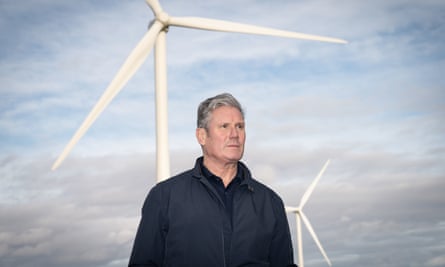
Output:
[{"xmin": 129, "ymin": 158, "xmax": 296, "ymax": 267}]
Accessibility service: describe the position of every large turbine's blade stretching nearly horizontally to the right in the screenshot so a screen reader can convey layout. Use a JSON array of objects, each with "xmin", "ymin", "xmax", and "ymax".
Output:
[{"xmin": 168, "ymin": 17, "xmax": 347, "ymax": 44}]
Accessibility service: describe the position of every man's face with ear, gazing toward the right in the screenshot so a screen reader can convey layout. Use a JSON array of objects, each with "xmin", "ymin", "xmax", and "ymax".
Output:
[{"xmin": 197, "ymin": 106, "xmax": 246, "ymax": 164}]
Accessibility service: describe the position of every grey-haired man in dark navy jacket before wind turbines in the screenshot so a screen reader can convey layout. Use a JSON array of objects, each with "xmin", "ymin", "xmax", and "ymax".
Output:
[{"xmin": 129, "ymin": 94, "xmax": 296, "ymax": 267}]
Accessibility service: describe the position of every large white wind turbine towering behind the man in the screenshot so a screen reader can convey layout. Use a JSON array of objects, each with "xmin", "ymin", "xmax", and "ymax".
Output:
[{"xmin": 52, "ymin": 0, "xmax": 346, "ymax": 181}]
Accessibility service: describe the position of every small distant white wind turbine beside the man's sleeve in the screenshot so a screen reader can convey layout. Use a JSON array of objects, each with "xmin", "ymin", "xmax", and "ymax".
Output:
[{"xmin": 286, "ymin": 160, "xmax": 332, "ymax": 267}]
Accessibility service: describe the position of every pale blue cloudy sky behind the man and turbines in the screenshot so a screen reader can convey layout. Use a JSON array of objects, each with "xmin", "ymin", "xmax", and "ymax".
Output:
[{"xmin": 0, "ymin": 0, "xmax": 445, "ymax": 267}]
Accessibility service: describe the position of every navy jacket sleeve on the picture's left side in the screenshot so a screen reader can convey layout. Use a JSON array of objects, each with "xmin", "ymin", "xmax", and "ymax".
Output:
[{"xmin": 128, "ymin": 186, "xmax": 167, "ymax": 267}]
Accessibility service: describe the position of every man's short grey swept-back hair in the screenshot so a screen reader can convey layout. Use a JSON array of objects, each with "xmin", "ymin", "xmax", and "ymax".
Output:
[{"xmin": 197, "ymin": 93, "xmax": 244, "ymax": 129}]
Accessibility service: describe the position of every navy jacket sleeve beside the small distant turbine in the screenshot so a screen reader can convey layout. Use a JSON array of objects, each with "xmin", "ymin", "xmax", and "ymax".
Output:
[{"xmin": 269, "ymin": 196, "xmax": 297, "ymax": 267}]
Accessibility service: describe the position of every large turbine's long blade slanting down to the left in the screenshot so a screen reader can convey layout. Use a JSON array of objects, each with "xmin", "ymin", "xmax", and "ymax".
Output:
[{"xmin": 51, "ymin": 22, "xmax": 164, "ymax": 170}]
